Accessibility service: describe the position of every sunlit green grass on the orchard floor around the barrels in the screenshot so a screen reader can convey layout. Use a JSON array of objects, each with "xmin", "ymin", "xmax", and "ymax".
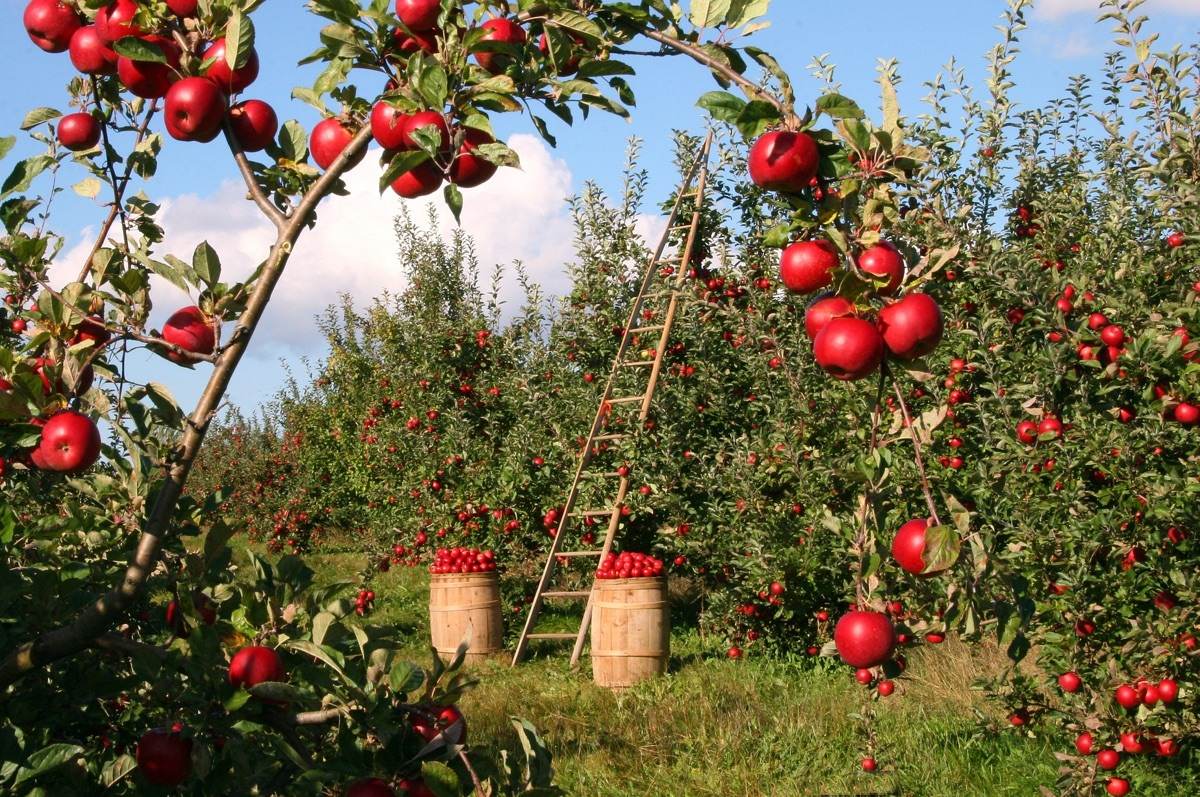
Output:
[{"xmin": 250, "ymin": 553, "xmax": 1183, "ymax": 797}]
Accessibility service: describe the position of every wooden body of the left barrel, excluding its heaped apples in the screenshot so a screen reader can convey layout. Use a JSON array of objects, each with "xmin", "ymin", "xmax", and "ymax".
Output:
[{"xmin": 430, "ymin": 571, "xmax": 504, "ymax": 664}]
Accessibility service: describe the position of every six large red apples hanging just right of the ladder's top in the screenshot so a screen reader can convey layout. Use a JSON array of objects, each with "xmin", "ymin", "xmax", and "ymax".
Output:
[{"xmin": 750, "ymin": 130, "xmax": 943, "ymax": 380}]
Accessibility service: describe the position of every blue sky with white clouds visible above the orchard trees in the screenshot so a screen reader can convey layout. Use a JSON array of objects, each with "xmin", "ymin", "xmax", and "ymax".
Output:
[{"xmin": 0, "ymin": 0, "xmax": 1200, "ymax": 406}]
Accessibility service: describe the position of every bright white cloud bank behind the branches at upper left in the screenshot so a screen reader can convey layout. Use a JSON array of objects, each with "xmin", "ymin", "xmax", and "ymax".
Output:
[{"xmin": 52, "ymin": 133, "xmax": 583, "ymax": 353}]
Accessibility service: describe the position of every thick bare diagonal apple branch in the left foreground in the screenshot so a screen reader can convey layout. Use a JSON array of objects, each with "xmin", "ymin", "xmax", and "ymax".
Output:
[{"xmin": 0, "ymin": 127, "xmax": 371, "ymax": 688}]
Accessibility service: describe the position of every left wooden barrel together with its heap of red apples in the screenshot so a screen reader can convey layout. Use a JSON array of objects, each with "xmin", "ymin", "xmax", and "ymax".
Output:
[{"xmin": 430, "ymin": 547, "xmax": 504, "ymax": 664}]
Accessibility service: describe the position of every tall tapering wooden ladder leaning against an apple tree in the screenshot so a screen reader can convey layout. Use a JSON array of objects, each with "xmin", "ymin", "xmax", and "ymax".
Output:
[{"xmin": 512, "ymin": 132, "xmax": 713, "ymax": 667}]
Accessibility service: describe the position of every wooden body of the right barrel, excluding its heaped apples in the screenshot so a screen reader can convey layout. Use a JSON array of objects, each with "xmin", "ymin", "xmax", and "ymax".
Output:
[{"xmin": 592, "ymin": 576, "xmax": 671, "ymax": 689}]
